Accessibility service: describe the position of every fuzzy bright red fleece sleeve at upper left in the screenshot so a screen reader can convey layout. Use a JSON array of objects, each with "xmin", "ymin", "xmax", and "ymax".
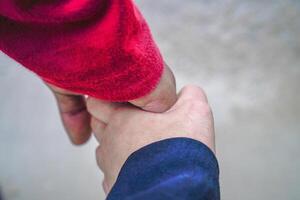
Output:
[{"xmin": 0, "ymin": 0, "xmax": 163, "ymax": 101}]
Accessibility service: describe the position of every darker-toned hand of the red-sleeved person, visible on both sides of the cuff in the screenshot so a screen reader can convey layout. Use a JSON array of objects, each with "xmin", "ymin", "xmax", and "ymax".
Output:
[{"xmin": 46, "ymin": 66, "xmax": 176, "ymax": 145}]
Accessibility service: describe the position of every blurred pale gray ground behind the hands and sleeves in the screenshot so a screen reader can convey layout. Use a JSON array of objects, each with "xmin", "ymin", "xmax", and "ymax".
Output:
[{"xmin": 0, "ymin": 0, "xmax": 300, "ymax": 200}]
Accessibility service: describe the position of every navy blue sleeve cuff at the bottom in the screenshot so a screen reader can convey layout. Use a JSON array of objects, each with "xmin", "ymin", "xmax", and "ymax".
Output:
[{"xmin": 107, "ymin": 138, "xmax": 220, "ymax": 200}]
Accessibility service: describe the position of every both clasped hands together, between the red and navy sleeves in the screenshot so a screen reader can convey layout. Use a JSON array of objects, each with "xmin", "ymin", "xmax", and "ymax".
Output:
[{"xmin": 48, "ymin": 67, "xmax": 215, "ymax": 193}]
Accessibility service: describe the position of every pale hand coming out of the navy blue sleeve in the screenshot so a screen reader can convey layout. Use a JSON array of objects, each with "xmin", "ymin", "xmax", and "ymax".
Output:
[{"xmin": 87, "ymin": 86, "xmax": 215, "ymax": 193}]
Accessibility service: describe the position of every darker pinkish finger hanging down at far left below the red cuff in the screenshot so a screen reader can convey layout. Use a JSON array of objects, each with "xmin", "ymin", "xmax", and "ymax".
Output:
[{"xmin": 54, "ymin": 91, "xmax": 91, "ymax": 145}]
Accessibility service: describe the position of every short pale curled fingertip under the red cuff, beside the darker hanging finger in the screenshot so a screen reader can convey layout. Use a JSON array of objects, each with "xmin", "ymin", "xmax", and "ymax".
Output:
[{"xmin": 87, "ymin": 97, "xmax": 120, "ymax": 124}]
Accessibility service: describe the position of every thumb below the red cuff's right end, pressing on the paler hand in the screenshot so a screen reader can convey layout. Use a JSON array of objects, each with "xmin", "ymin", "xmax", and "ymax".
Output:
[{"xmin": 129, "ymin": 65, "xmax": 177, "ymax": 112}]
